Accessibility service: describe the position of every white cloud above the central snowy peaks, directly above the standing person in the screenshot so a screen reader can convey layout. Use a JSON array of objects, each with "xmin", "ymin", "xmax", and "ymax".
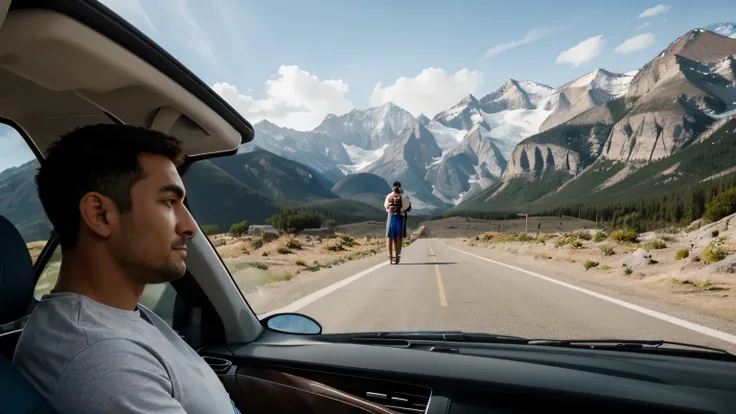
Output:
[{"xmin": 370, "ymin": 68, "xmax": 483, "ymax": 118}]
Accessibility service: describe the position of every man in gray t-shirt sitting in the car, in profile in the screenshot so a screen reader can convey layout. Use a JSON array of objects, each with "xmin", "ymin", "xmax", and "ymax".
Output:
[{"xmin": 13, "ymin": 125, "xmax": 242, "ymax": 414}]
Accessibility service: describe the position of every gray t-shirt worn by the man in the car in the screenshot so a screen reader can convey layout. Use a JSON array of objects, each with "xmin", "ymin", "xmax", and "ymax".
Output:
[{"xmin": 13, "ymin": 293, "xmax": 233, "ymax": 414}]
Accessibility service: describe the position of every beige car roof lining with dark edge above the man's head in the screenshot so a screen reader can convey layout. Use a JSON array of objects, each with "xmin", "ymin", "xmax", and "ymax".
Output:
[{"xmin": 0, "ymin": 5, "xmax": 252, "ymax": 157}]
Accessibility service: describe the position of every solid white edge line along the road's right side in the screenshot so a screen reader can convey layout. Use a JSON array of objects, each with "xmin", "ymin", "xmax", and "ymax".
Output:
[{"xmin": 443, "ymin": 242, "xmax": 736, "ymax": 344}]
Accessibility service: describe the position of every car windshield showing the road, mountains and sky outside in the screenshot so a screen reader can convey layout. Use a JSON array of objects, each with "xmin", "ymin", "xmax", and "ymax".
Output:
[{"xmin": 5, "ymin": 0, "xmax": 736, "ymax": 351}]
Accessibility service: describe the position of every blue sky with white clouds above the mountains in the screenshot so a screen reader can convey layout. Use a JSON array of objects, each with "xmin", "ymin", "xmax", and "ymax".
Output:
[{"xmin": 0, "ymin": 0, "xmax": 736, "ymax": 170}]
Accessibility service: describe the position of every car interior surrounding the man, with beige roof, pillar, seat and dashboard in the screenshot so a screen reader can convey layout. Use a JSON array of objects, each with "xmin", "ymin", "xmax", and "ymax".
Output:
[{"xmin": 0, "ymin": 0, "xmax": 736, "ymax": 414}]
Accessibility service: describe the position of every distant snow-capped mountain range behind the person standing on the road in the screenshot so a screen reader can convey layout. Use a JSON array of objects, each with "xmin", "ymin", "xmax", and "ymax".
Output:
[{"xmin": 242, "ymin": 69, "xmax": 637, "ymax": 211}]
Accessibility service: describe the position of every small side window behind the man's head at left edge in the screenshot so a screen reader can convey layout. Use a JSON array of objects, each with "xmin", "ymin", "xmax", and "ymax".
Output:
[{"xmin": 0, "ymin": 124, "xmax": 51, "ymax": 262}]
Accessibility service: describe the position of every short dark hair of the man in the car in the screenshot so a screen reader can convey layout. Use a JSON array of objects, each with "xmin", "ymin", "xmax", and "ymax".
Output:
[{"xmin": 36, "ymin": 124, "xmax": 184, "ymax": 248}]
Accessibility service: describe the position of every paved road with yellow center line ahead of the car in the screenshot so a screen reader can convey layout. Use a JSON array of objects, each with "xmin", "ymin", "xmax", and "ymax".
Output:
[{"xmin": 299, "ymin": 239, "xmax": 736, "ymax": 351}]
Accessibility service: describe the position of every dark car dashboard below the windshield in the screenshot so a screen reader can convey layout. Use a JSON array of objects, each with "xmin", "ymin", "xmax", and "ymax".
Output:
[{"xmin": 200, "ymin": 333, "xmax": 736, "ymax": 414}]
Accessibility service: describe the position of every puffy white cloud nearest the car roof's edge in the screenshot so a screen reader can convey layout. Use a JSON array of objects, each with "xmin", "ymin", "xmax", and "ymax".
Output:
[{"xmin": 212, "ymin": 65, "xmax": 353, "ymax": 131}]
